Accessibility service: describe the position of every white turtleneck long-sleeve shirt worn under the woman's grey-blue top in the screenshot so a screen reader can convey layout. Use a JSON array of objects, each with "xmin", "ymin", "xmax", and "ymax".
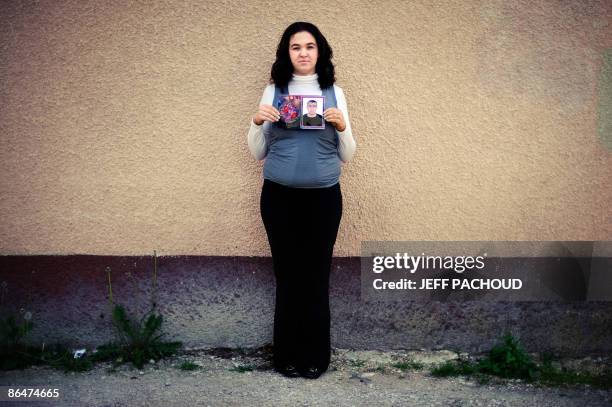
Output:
[{"xmin": 247, "ymin": 73, "xmax": 357, "ymax": 162}]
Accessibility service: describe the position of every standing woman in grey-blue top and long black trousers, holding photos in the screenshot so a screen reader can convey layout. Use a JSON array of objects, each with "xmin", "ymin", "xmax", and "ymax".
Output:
[{"xmin": 247, "ymin": 22, "xmax": 356, "ymax": 379}]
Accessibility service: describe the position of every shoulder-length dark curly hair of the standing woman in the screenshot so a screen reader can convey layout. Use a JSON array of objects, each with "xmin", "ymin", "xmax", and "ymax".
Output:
[{"xmin": 270, "ymin": 21, "xmax": 336, "ymax": 89}]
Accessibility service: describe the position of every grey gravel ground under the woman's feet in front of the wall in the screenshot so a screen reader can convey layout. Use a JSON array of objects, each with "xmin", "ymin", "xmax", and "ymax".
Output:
[{"xmin": 0, "ymin": 349, "xmax": 612, "ymax": 407}]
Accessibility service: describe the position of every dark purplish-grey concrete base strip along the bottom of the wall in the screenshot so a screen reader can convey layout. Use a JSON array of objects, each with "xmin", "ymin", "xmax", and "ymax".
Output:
[{"xmin": 0, "ymin": 255, "xmax": 612, "ymax": 356}]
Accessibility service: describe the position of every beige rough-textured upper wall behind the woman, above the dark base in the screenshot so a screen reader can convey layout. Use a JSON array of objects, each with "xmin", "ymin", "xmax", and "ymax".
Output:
[{"xmin": 0, "ymin": 0, "xmax": 612, "ymax": 256}]
